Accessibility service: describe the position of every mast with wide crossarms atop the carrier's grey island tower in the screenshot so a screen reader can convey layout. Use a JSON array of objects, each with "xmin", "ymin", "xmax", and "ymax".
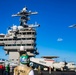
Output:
[{"xmin": 12, "ymin": 7, "xmax": 40, "ymax": 27}]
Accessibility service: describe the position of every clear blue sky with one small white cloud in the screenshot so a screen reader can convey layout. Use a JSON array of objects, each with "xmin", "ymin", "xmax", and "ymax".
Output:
[{"xmin": 0, "ymin": 0, "xmax": 76, "ymax": 63}]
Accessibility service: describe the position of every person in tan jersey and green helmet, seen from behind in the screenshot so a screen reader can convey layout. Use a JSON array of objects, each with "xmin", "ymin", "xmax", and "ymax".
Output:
[{"xmin": 14, "ymin": 54, "xmax": 34, "ymax": 75}]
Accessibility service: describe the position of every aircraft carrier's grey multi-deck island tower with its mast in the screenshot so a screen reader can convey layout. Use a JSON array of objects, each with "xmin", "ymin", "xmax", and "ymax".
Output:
[{"xmin": 0, "ymin": 7, "xmax": 40, "ymax": 63}]
